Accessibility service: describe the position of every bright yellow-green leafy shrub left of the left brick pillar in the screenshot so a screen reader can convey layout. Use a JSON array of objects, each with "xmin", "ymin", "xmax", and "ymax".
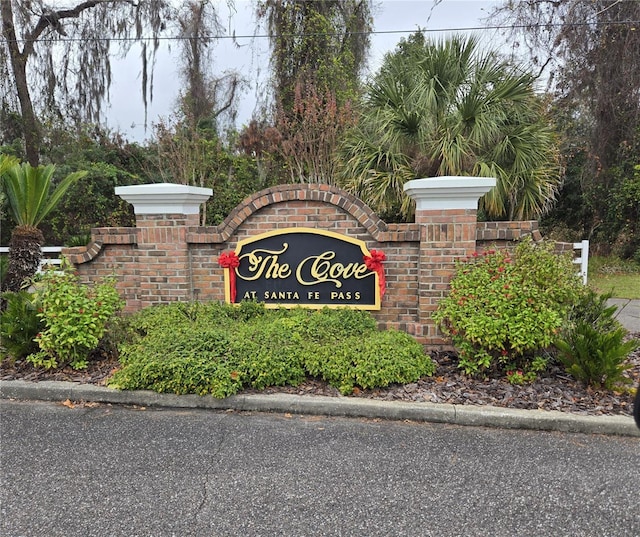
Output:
[{"xmin": 27, "ymin": 267, "xmax": 124, "ymax": 369}]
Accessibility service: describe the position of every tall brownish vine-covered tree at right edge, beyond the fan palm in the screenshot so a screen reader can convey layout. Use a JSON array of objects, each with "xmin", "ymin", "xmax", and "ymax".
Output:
[{"xmin": 491, "ymin": 0, "xmax": 640, "ymax": 256}]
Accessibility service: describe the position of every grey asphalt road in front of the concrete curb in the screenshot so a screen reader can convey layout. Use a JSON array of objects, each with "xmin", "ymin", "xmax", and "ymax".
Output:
[{"xmin": 0, "ymin": 400, "xmax": 640, "ymax": 537}]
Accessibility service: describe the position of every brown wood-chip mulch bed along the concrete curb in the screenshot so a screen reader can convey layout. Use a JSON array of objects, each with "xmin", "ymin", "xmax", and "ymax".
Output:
[{"xmin": 0, "ymin": 332, "xmax": 640, "ymax": 416}]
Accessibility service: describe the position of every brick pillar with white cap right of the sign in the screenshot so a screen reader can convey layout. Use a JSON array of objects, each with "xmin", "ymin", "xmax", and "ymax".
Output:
[{"xmin": 404, "ymin": 177, "xmax": 496, "ymax": 347}]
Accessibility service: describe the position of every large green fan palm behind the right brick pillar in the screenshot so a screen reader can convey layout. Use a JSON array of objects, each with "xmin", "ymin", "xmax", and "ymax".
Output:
[{"xmin": 341, "ymin": 32, "xmax": 560, "ymax": 220}]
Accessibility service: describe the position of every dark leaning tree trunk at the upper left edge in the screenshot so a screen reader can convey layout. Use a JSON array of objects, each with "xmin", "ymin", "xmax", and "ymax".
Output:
[{"xmin": 0, "ymin": 0, "xmax": 40, "ymax": 166}]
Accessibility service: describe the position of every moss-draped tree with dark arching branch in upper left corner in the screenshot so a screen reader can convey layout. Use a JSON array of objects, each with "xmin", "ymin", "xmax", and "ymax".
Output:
[{"xmin": 0, "ymin": 0, "xmax": 174, "ymax": 166}]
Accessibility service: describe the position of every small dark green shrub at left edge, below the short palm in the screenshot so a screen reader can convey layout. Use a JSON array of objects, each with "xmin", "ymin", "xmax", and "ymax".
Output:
[{"xmin": 0, "ymin": 291, "xmax": 44, "ymax": 361}]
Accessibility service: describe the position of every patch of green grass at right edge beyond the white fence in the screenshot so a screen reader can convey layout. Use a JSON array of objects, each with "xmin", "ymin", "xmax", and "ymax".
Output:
[{"xmin": 588, "ymin": 256, "xmax": 640, "ymax": 299}]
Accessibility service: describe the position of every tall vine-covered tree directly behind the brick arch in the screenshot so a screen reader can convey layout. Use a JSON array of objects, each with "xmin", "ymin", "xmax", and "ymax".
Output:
[{"xmin": 258, "ymin": 0, "xmax": 372, "ymax": 183}]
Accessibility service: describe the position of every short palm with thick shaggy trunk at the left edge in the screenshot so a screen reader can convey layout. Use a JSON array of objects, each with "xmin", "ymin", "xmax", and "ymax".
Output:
[{"xmin": 2, "ymin": 159, "xmax": 87, "ymax": 292}]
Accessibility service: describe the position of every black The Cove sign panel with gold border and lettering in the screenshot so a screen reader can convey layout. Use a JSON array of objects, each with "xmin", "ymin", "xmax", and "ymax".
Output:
[{"xmin": 225, "ymin": 228, "xmax": 380, "ymax": 310}]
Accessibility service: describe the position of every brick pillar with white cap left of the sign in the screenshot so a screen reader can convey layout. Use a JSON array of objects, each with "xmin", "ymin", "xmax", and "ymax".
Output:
[{"xmin": 116, "ymin": 183, "xmax": 212, "ymax": 309}]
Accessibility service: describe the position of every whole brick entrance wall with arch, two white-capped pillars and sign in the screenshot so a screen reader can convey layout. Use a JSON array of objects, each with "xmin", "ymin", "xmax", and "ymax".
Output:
[{"xmin": 62, "ymin": 177, "xmax": 539, "ymax": 348}]
